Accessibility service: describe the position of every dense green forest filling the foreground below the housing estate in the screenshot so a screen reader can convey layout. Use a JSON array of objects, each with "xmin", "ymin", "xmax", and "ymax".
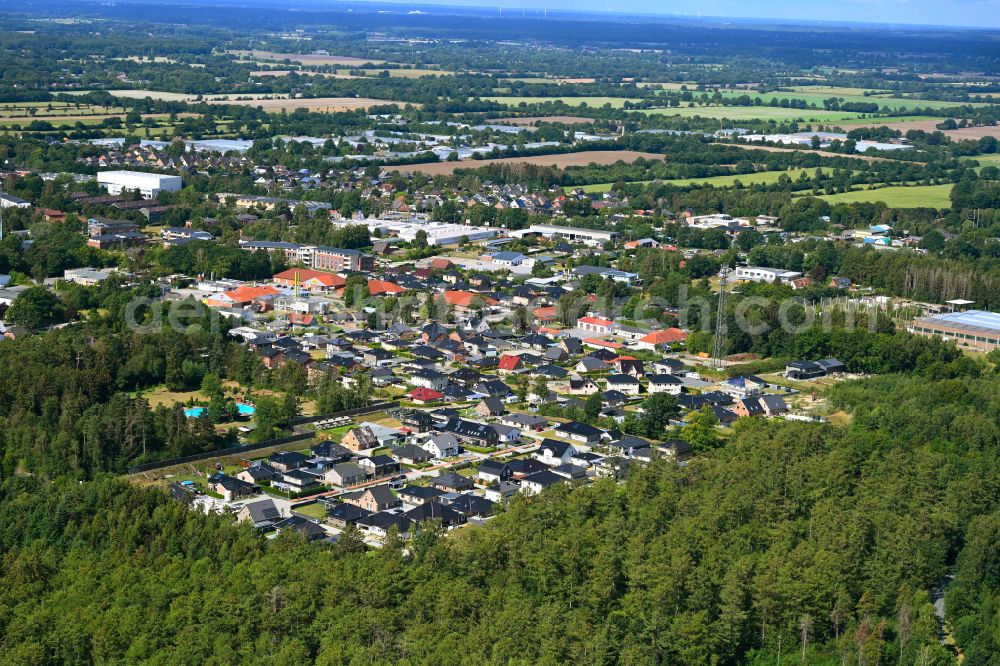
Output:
[{"xmin": 0, "ymin": 371, "xmax": 1000, "ymax": 665}]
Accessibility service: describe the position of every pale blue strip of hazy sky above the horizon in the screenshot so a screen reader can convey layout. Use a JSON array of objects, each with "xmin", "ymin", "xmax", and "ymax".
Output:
[{"xmin": 364, "ymin": 0, "xmax": 1000, "ymax": 28}]
